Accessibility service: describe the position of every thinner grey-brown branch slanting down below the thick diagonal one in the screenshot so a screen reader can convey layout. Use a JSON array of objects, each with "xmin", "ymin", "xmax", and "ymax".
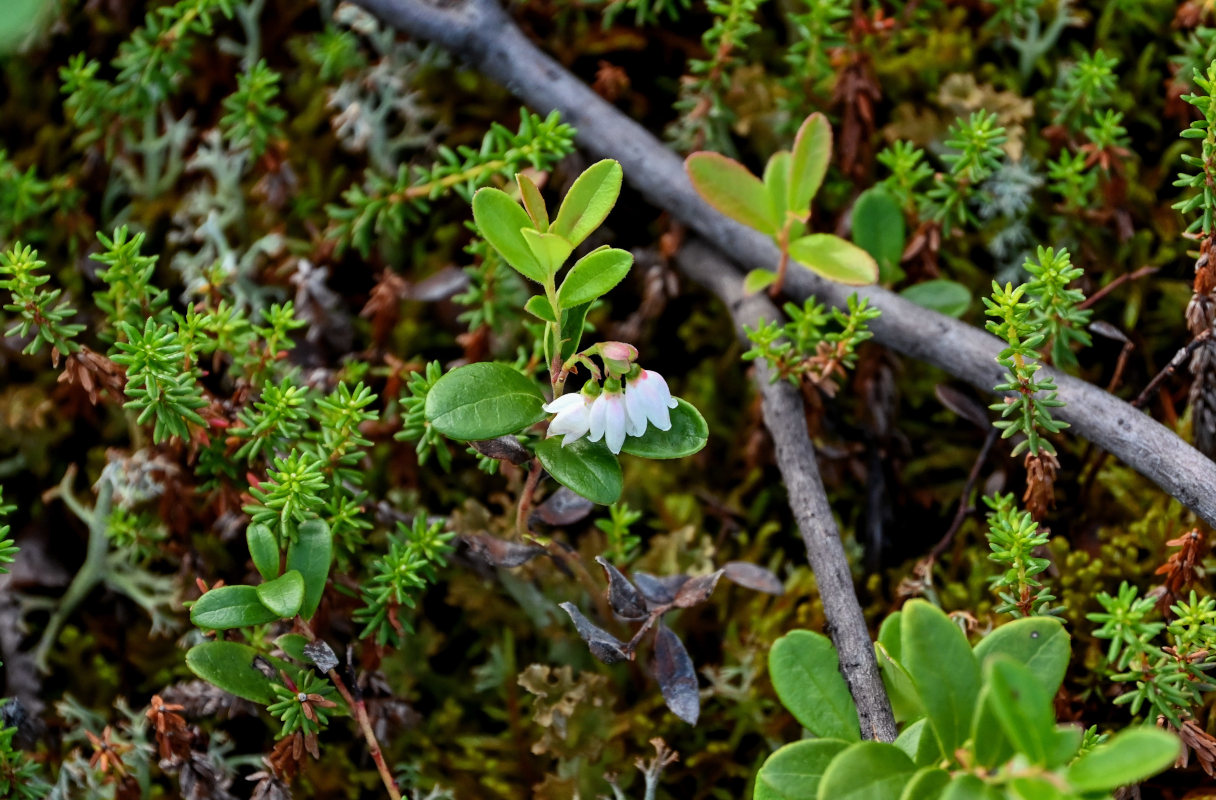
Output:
[{"xmin": 676, "ymin": 242, "xmax": 899, "ymax": 742}]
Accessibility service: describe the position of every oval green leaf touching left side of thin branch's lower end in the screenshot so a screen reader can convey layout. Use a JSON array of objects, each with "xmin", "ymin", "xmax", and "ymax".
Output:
[{"xmin": 769, "ymin": 631, "xmax": 861, "ymax": 742}]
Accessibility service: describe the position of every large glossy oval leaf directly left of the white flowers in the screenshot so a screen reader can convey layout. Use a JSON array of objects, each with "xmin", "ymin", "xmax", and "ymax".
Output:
[{"xmin": 426, "ymin": 361, "xmax": 545, "ymax": 441}]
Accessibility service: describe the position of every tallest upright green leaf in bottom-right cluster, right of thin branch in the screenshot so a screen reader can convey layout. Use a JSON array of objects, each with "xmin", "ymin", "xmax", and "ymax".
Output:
[{"xmin": 900, "ymin": 599, "xmax": 980, "ymax": 754}]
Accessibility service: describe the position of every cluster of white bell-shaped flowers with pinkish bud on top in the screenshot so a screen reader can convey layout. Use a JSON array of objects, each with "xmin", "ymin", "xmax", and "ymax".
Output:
[{"xmin": 544, "ymin": 342, "xmax": 676, "ymax": 453}]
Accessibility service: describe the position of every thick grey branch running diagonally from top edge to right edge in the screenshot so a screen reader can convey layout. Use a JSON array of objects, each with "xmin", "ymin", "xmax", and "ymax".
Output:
[{"xmin": 354, "ymin": 0, "xmax": 1216, "ymax": 525}]
